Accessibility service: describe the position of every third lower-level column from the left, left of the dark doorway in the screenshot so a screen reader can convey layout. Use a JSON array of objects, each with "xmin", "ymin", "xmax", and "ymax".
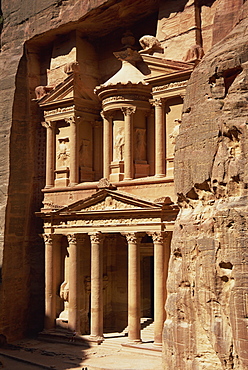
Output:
[{"xmin": 89, "ymin": 232, "xmax": 103, "ymax": 341}]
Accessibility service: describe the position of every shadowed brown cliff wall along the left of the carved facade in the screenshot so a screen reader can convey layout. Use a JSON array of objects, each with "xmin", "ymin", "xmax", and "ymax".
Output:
[{"xmin": 0, "ymin": 0, "xmax": 111, "ymax": 340}]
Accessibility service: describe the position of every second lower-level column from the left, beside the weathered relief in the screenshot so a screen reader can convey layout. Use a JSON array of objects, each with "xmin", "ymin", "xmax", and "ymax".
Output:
[{"xmin": 67, "ymin": 234, "xmax": 80, "ymax": 332}]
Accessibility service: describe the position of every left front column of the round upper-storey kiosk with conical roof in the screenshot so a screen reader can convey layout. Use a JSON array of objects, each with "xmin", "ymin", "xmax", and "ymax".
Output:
[{"xmin": 101, "ymin": 111, "xmax": 113, "ymax": 179}]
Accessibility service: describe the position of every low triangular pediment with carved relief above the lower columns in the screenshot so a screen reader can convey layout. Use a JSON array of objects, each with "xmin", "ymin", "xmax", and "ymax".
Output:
[{"xmin": 56, "ymin": 189, "xmax": 162, "ymax": 214}]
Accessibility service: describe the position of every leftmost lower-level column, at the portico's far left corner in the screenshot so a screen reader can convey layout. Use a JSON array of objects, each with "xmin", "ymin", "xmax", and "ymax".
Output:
[{"xmin": 43, "ymin": 234, "xmax": 56, "ymax": 330}]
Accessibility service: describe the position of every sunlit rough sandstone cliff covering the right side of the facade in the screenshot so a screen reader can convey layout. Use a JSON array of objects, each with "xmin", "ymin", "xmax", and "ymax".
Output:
[{"xmin": 164, "ymin": 3, "xmax": 248, "ymax": 370}]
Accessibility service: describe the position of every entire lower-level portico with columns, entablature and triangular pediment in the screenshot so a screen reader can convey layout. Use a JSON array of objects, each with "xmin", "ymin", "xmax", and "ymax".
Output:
[{"xmin": 38, "ymin": 189, "xmax": 177, "ymax": 345}]
